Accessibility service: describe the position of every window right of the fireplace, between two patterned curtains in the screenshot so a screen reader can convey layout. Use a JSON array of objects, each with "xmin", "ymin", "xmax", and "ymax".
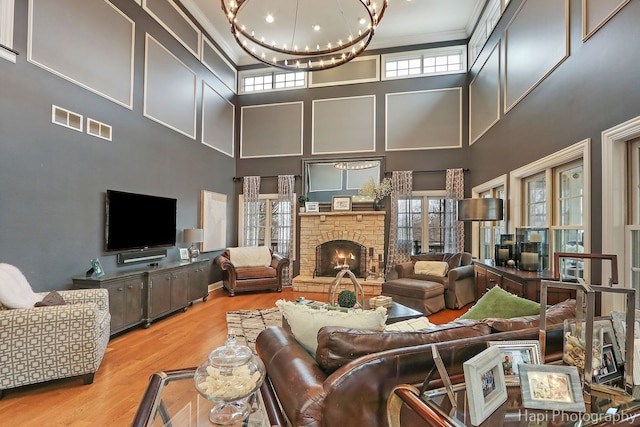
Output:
[{"xmin": 398, "ymin": 191, "xmax": 446, "ymax": 254}]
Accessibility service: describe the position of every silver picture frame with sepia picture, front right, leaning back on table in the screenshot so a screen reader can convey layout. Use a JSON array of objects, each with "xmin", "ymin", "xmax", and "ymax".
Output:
[{"xmin": 519, "ymin": 365, "xmax": 586, "ymax": 412}]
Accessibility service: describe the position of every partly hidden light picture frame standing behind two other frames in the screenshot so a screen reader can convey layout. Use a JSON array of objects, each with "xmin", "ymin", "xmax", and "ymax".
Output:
[{"xmin": 488, "ymin": 340, "xmax": 542, "ymax": 386}]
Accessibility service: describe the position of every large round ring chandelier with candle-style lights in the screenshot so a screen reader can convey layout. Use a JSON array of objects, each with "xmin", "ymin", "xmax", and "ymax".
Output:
[{"xmin": 221, "ymin": 0, "xmax": 388, "ymax": 71}]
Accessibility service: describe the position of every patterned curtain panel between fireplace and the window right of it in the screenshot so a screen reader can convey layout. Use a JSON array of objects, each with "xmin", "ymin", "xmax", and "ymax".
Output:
[{"xmin": 385, "ymin": 171, "xmax": 413, "ymax": 275}]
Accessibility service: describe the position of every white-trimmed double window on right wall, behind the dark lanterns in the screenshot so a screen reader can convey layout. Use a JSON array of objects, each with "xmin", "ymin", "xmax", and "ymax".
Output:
[{"xmin": 511, "ymin": 140, "xmax": 591, "ymax": 279}]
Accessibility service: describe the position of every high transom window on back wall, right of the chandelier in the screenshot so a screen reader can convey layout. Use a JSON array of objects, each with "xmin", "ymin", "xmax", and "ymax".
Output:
[{"xmin": 382, "ymin": 46, "xmax": 466, "ymax": 80}]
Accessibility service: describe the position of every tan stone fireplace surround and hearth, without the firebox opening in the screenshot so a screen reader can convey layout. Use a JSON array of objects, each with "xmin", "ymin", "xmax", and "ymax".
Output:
[{"xmin": 293, "ymin": 211, "xmax": 385, "ymax": 296}]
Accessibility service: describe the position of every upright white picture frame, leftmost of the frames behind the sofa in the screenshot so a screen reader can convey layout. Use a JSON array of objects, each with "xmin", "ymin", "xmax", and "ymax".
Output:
[{"xmin": 462, "ymin": 346, "xmax": 507, "ymax": 426}]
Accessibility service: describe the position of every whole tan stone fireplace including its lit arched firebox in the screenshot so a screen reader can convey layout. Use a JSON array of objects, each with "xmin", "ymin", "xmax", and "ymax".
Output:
[{"xmin": 293, "ymin": 211, "xmax": 385, "ymax": 295}]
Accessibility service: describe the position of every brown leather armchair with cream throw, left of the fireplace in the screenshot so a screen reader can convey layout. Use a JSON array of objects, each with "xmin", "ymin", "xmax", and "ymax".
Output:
[{"xmin": 216, "ymin": 247, "xmax": 289, "ymax": 296}]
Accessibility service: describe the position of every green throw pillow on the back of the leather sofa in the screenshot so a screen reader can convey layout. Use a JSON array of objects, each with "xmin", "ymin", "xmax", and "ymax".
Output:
[{"xmin": 460, "ymin": 286, "xmax": 540, "ymax": 320}]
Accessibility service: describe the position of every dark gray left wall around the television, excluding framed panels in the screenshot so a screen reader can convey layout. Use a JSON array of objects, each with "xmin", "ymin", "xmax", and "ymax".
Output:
[{"xmin": 0, "ymin": 0, "xmax": 237, "ymax": 291}]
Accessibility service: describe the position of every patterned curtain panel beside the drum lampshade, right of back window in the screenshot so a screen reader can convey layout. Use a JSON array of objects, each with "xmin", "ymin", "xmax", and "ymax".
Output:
[{"xmin": 444, "ymin": 169, "xmax": 464, "ymax": 253}]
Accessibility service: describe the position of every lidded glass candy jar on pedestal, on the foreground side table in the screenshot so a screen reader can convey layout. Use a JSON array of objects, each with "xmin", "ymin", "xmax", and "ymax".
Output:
[{"xmin": 193, "ymin": 332, "xmax": 266, "ymax": 425}]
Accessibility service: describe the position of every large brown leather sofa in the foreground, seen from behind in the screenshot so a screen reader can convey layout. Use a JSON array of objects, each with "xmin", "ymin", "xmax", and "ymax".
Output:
[{"xmin": 256, "ymin": 300, "xmax": 575, "ymax": 427}]
